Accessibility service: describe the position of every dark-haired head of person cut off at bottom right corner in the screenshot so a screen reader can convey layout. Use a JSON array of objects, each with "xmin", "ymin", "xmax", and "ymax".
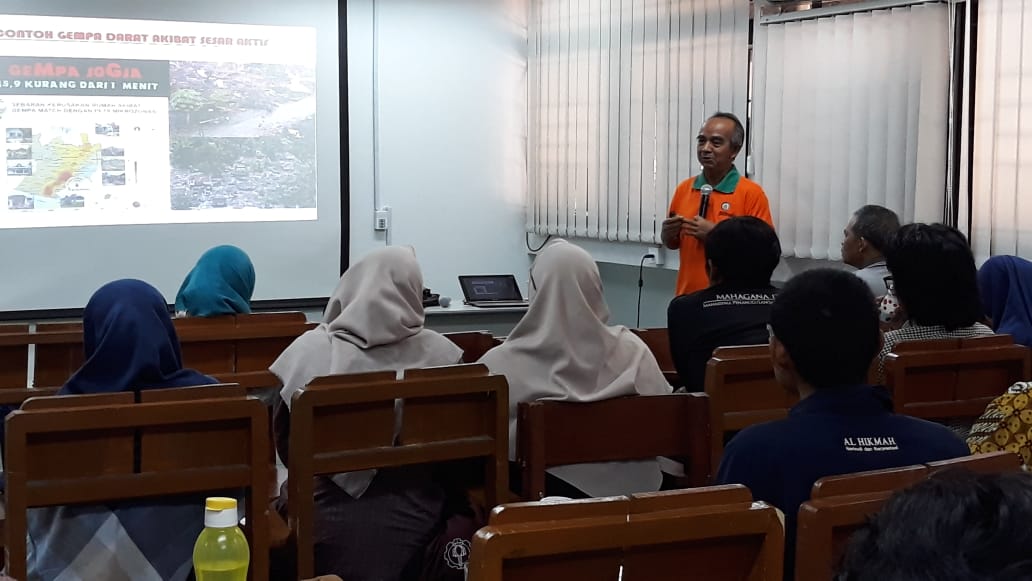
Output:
[{"xmin": 836, "ymin": 470, "xmax": 1032, "ymax": 581}]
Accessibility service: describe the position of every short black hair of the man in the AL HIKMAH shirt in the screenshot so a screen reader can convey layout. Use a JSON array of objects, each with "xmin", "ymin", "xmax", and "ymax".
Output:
[{"xmin": 771, "ymin": 268, "xmax": 881, "ymax": 389}]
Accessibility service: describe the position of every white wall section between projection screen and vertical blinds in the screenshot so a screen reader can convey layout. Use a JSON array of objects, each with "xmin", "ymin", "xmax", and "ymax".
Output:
[{"xmin": 348, "ymin": 0, "xmax": 529, "ymax": 299}]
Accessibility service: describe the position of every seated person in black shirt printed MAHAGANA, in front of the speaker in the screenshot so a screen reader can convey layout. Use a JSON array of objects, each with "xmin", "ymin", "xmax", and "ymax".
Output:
[{"xmin": 667, "ymin": 216, "xmax": 781, "ymax": 391}]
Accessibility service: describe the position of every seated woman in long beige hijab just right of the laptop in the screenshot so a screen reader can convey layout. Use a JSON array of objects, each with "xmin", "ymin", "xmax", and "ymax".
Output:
[{"xmin": 480, "ymin": 239, "xmax": 671, "ymax": 497}]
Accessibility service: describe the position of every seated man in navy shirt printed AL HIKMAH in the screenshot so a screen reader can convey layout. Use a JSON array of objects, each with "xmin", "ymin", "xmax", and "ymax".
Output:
[{"xmin": 716, "ymin": 268, "xmax": 968, "ymax": 579}]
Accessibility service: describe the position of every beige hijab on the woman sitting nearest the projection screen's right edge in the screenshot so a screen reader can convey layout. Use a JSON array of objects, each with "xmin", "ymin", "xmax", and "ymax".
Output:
[{"xmin": 269, "ymin": 247, "xmax": 462, "ymax": 498}]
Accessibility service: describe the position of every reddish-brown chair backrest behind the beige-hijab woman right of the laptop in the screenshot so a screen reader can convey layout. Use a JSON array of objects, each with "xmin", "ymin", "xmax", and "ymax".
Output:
[{"xmin": 516, "ymin": 393, "xmax": 712, "ymax": 501}]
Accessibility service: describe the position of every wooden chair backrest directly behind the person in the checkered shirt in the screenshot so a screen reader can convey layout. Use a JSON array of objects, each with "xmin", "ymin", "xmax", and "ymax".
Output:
[{"xmin": 885, "ymin": 335, "xmax": 1032, "ymax": 420}]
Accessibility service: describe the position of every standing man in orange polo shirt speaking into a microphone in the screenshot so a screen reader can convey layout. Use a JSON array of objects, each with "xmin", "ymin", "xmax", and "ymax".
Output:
[{"xmin": 662, "ymin": 112, "xmax": 774, "ymax": 295}]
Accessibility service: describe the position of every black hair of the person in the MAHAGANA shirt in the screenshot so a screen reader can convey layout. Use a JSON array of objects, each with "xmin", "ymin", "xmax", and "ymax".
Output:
[{"xmin": 704, "ymin": 216, "xmax": 781, "ymax": 287}]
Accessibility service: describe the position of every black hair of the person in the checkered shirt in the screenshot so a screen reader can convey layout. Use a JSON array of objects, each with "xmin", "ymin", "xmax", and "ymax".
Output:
[{"xmin": 885, "ymin": 224, "xmax": 983, "ymax": 330}]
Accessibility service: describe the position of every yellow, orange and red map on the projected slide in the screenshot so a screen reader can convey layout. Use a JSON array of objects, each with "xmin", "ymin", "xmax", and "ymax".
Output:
[{"xmin": 14, "ymin": 129, "xmax": 100, "ymax": 198}]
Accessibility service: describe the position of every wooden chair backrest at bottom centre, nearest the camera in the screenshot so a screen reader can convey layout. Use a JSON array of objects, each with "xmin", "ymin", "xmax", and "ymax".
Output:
[{"xmin": 469, "ymin": 488, "xmax": 784, "ymax": 581}]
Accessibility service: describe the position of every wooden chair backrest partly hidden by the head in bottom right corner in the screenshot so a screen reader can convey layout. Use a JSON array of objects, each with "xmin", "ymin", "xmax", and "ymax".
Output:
[{"xmin": 796, "ymin": 490, "xmax": 893, "ymax": 581}]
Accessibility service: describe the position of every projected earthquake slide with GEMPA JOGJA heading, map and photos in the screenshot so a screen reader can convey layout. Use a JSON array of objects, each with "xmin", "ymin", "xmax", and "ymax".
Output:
[{"xmin": 0, "ymin": 15, "xmax": 318, "ymax": 228}]
